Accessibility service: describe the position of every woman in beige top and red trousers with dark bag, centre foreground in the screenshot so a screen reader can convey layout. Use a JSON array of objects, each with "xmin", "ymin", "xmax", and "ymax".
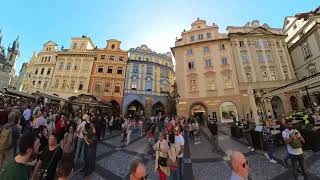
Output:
[{"xmin": 153, "ymin": 132, "xmax": 170, "ymax": 180}]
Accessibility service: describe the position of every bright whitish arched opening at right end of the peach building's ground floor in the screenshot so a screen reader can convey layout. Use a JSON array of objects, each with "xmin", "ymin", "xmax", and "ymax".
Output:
[{"xmin": 220, "ymin": 101, "xmax": 239, "ymax": 123}]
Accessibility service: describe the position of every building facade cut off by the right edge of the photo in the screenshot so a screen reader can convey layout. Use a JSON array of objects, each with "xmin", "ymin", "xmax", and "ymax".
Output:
[{"xmin": 283, "ymin": 7, "xmax": 320, "ymax": 109}]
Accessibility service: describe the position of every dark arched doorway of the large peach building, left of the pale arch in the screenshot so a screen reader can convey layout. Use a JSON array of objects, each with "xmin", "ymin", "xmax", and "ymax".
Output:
[{"xmin": 189, "ymin": 102, "xmax": 208, "ymax": 125}]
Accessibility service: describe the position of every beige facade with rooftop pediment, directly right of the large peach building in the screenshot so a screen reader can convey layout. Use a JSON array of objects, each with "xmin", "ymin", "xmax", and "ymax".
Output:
[{"xmin": 227, "ymin": 20, "xmax": 296, "ymax": 119}]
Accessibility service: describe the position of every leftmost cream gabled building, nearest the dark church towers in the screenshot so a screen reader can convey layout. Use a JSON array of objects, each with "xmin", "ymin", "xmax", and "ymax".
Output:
[{"xmin": 21, "ymin": 41, "xmax": 57, "ymax": 93}]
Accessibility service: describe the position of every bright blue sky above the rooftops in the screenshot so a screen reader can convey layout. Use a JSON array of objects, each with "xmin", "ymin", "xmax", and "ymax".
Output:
[{"xmin": 0, "ymin": 0, "xmax": 320, "ymax": 73}]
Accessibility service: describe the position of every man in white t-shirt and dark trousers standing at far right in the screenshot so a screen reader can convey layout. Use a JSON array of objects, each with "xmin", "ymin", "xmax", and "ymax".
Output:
[{"xmin": 282, "ymin": 120, "xmax": 308, "ymax": 180}]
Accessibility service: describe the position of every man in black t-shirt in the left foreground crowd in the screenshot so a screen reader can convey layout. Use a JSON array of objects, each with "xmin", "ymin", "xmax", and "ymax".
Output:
[{"xmin": 34, "ymin": 134, "xmax": 63, "ymax": 180}]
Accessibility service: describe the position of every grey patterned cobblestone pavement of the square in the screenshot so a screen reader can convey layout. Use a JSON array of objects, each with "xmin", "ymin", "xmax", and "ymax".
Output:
[{"xmin": 72, "ymin": 126, "xmax": 320, "ymax": 180}]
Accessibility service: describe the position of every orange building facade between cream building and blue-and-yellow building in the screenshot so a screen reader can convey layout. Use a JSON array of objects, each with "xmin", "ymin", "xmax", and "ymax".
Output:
[{"xmin": 88, "ymin": 39, "xmax": 128, "ymax": 113}]
